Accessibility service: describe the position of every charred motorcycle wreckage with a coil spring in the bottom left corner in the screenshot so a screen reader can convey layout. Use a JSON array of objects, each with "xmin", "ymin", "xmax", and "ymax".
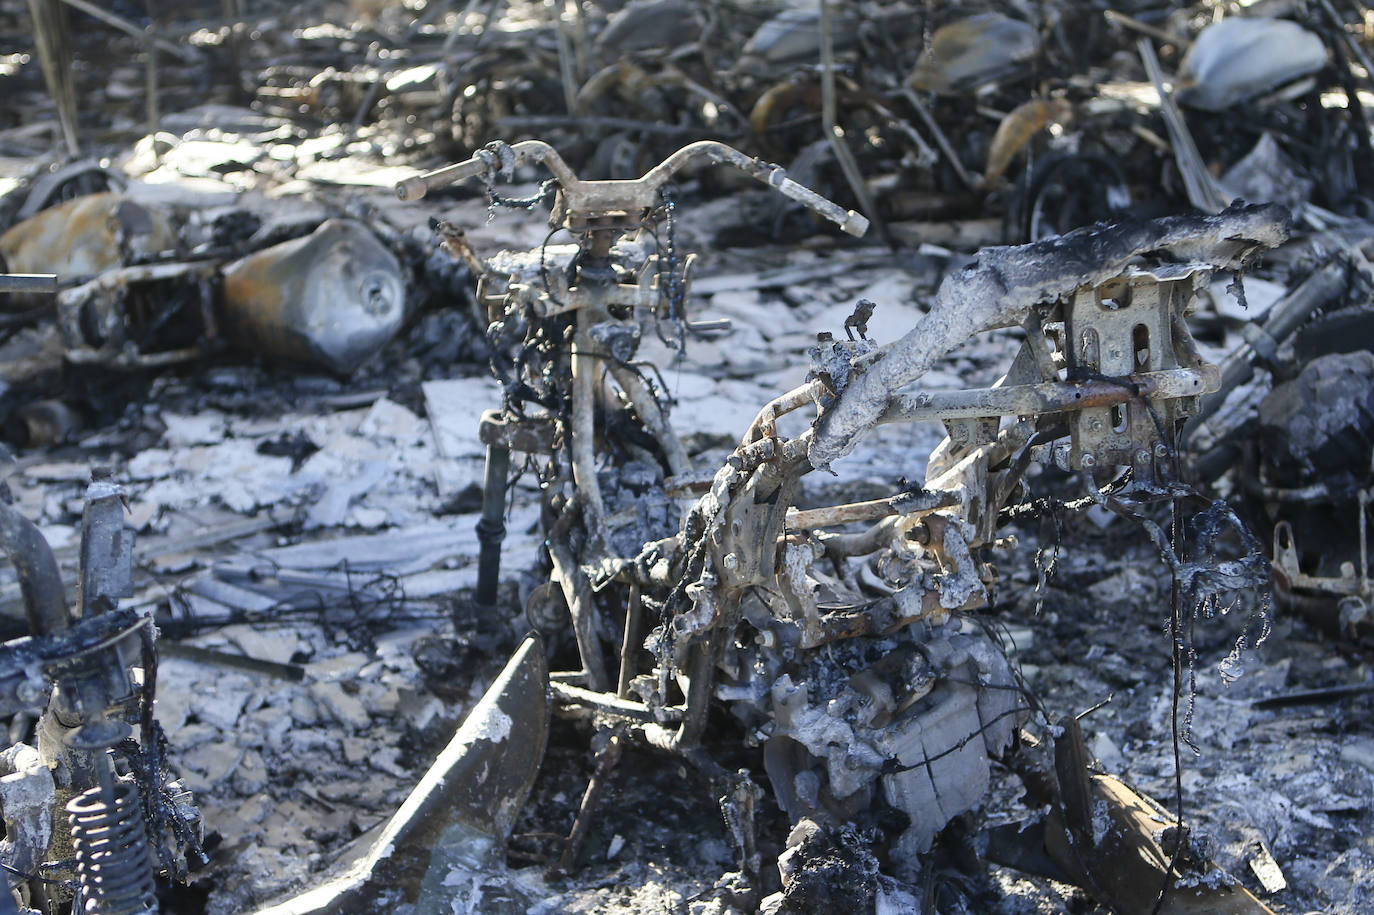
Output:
[{"xmin": 0, "ymin": 449, "xmax": 205, "ymax": 915}]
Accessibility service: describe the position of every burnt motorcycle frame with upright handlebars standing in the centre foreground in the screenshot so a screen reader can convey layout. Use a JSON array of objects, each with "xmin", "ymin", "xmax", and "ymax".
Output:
[{"xmin": 239, "ymin": 133, "xmax": 1287, "ymax": 914}]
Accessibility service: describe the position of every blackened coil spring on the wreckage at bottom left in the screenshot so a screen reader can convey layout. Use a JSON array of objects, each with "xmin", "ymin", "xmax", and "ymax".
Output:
[{"xmin": 67, "ymin": 782, "xmax": 158, "ymax": 915}]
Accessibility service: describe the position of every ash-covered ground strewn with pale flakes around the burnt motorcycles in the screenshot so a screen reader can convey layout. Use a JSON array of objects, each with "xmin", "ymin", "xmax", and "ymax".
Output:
[{"xmin": 0, "ymin": 4, "xmax": 1374, "ymax": 915}]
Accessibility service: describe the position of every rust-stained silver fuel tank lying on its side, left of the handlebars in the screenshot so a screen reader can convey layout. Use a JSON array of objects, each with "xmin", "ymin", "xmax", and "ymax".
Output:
[{"xmin": 221, "ymin": 220, "xmax": 405, "ymax": 375}]
